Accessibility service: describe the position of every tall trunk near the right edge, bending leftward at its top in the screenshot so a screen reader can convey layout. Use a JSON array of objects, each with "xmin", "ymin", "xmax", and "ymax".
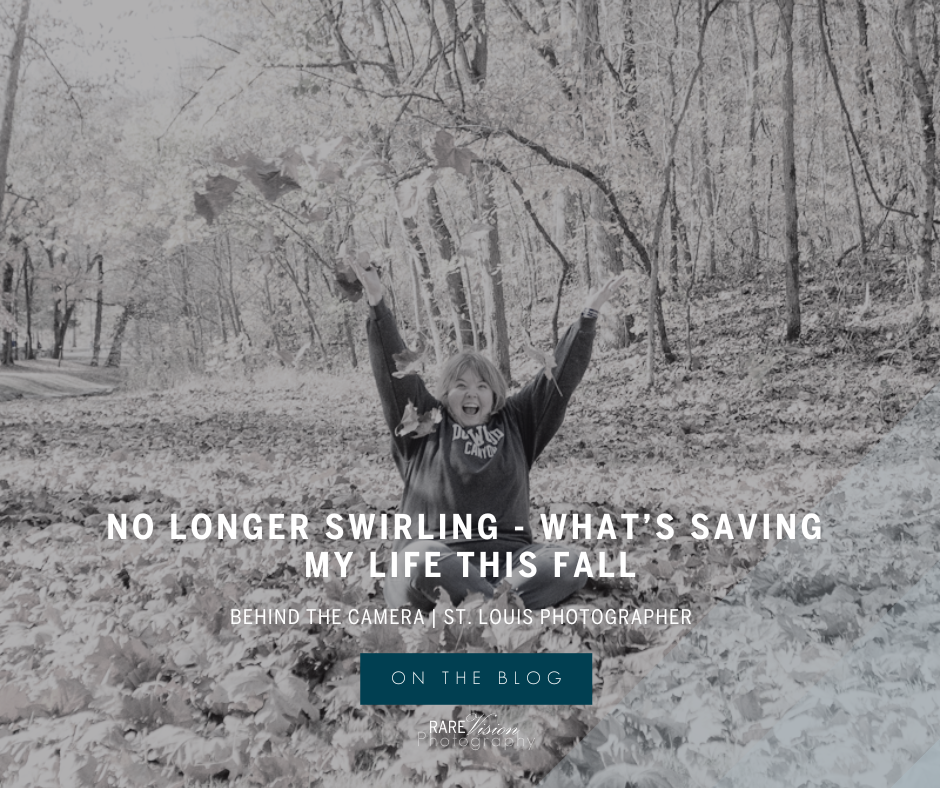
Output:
[{"xmin": 898, "ymin": 0, "xmax": 937, "ymax": 301}]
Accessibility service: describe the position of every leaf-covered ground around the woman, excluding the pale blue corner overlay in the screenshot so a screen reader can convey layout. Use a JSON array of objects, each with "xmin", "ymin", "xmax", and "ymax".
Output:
[{"xmin": 0, "ymin": 278, "xmax": 940, "ymax": 786}]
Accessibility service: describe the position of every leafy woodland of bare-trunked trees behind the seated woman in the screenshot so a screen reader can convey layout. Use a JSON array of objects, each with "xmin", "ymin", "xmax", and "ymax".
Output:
[{"xmin": 0, "ymin": 0, "xmax": 937, "ymax": 384}]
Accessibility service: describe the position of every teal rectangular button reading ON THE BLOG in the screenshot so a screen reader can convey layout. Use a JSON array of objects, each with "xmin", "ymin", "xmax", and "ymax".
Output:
[{"xmin": 359, "ymin": 654, "xmax": 593, "ymax": 706}]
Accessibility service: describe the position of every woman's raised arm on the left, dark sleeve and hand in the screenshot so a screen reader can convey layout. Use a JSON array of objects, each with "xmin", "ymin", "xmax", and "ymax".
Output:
[{"xmin": 352, "ymin": 263, "xmax": 437, "ymax": 454}]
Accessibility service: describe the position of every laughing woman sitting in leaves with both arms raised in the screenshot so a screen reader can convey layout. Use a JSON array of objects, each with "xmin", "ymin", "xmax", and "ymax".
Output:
[{"xmin": 354, "ymin": 266, "xmax": 626, "ymax": 610}]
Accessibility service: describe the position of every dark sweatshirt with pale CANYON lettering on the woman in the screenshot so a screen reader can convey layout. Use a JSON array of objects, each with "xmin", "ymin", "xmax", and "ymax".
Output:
[{"xmin": 368, "ymin": 301, "xmax": 596, "ymax": 553}]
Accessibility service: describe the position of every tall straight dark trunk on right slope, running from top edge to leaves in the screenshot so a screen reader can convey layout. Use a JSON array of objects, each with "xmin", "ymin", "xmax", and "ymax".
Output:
[{"xmin": 778, "ymin": 0, "xmax": 800, "ymax": 342}]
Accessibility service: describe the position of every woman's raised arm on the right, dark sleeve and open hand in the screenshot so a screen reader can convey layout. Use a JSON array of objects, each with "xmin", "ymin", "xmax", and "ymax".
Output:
[{"xmin": 506, "ymin": 274, "xmax": 627, "ymax": 466}]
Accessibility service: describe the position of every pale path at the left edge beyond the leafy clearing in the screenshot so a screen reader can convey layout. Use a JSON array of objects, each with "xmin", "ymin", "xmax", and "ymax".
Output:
[{"xmin": 0, "ymin": 359, "xmax": 123, "ymax": 402}]
